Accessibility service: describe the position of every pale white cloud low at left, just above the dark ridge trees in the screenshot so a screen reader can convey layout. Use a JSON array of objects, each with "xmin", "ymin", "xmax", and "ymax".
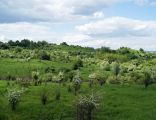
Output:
[{"xmin": 0, "ymin": 22, "xmax": 58, "ymax": 43}]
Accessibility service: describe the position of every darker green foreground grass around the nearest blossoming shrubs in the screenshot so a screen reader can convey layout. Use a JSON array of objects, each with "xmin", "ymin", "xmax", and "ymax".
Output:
[{"xmin": 0, "ymin": 81, "xmax": 156, "ymax": 120}]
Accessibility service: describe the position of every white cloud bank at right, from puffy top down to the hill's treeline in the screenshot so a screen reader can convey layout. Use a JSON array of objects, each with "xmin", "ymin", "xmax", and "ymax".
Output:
[{"xmin": 61, "ymin": 17, "xmax": 156, "ymax": 50}]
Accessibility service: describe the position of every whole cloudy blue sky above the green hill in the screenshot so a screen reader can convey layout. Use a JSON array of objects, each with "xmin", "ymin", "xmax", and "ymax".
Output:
[{"xmin": 0, "ymin": 0, "xmax": 156, "ymax": 51}]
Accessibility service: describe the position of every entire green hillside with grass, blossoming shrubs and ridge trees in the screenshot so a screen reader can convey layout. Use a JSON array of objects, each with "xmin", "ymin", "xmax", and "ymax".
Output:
[{"xmin": 0, "ymin": 39, "xmax": 156, "ymax": 120}]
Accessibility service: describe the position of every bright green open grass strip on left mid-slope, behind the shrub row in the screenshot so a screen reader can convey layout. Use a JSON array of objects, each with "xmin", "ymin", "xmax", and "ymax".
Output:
[{"xmin": 0, "ymin": 58, "xmax": 72, "ymax": 77}]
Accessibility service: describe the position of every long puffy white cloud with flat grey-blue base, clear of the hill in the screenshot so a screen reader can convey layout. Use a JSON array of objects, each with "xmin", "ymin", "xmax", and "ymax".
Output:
[{"xmin": 76, "ymin": 17, "xmax": 156, "ymax": 37}]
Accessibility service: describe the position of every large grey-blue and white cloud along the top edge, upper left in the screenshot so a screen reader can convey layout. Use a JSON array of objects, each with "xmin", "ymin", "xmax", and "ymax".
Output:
[{"xmin": 0, "ymin": 0, "xmax": 120, "ymax": 21}]
